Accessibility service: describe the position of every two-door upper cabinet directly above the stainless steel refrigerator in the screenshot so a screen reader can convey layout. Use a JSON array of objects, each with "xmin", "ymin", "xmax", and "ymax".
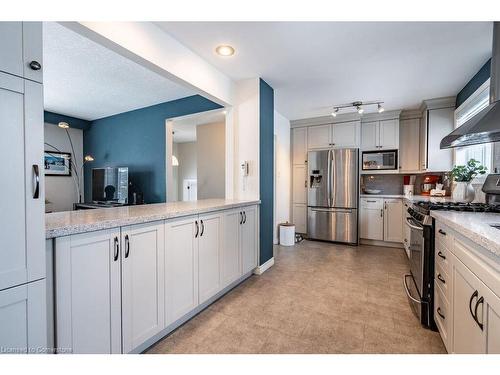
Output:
[{"xmin": 307, "ymin": 121, "xmax": 360, "ymax": 149}]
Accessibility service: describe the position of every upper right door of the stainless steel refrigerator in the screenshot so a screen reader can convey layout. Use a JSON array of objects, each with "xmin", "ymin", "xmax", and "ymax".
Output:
[{"xmin": 330, "ymin": 148, "xmax": 358, "ymax": 208}]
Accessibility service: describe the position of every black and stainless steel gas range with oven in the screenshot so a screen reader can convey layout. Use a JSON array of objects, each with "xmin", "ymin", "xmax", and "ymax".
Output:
[{"xmin": 403, "ymin": 198, "xmax": 500, "ymax": 330}]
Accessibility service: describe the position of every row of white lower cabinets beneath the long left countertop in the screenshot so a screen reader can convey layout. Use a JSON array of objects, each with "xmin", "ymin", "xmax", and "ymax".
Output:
[{"xmin": 53, "ymin": 206, "xmax": 258, "ymax": 353}]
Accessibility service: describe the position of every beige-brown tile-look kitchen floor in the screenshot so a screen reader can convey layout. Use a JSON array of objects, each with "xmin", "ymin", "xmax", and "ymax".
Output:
[{"xmin": 147, "ymin": 241, "xmax": 446, "ymax": 354}]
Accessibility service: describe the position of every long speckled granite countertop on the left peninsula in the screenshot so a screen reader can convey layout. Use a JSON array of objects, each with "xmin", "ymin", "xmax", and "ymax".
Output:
[{"xmin": 45, "ymin": 199, "xmax": 260, "ymax": 239}]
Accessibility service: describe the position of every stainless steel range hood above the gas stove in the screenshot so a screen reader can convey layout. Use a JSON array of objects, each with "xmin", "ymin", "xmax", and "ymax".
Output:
[{"xmin": 440, "ymin": 22, "xmax": 500, "ymax": 148}]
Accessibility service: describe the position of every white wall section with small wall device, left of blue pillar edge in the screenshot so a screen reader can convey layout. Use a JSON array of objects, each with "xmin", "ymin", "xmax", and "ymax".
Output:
[{"xmin": 233, "ymin": 78, "xmax": 260, "ymax": 200}]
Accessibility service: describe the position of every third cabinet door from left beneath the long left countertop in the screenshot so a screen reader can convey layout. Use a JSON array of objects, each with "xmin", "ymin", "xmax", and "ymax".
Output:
[{"xmin": 165, "ymin": 216, "xmax": 199, "ymax": 326}]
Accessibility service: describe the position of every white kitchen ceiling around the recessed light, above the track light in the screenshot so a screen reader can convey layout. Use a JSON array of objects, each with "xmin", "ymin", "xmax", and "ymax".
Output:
[{"xmin": 157, "ymin": 22, "xmax": 492, "ymax": 119}]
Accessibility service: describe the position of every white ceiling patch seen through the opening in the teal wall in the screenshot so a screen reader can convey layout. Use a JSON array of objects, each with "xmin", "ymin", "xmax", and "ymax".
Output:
[{"xmin": 172, "ymin": 110, "xmax": 226, "ymax": 143}]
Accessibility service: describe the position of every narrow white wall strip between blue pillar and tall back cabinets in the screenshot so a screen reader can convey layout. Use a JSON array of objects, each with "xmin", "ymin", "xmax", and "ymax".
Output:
[{"xmin": 274, "ymin": 111, "xmax": 292, "ymax": 243}]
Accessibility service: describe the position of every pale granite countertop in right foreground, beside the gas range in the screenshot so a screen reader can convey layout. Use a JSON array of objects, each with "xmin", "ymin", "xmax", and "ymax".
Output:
[{"xmin": 431, "ymin": 211, "xmax": 500, "ymax": 256}]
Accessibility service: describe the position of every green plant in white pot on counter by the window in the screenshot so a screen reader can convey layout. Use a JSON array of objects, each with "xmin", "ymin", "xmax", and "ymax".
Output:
[{"xmin": 451, "ymin": 159, "xmax": 488, "ymax": 203}]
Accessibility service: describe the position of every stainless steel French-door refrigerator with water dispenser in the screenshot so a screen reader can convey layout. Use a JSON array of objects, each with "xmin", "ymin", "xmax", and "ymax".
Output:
[{"xmin": 307, "ymin": 148, "xmax": 359, "ymax": 244}]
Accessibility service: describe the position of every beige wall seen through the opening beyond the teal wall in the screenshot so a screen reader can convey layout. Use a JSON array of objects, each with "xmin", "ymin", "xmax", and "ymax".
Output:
[{"xmin": 196, "ymin": 122, "xmax": 226, "ymax": 199}]
